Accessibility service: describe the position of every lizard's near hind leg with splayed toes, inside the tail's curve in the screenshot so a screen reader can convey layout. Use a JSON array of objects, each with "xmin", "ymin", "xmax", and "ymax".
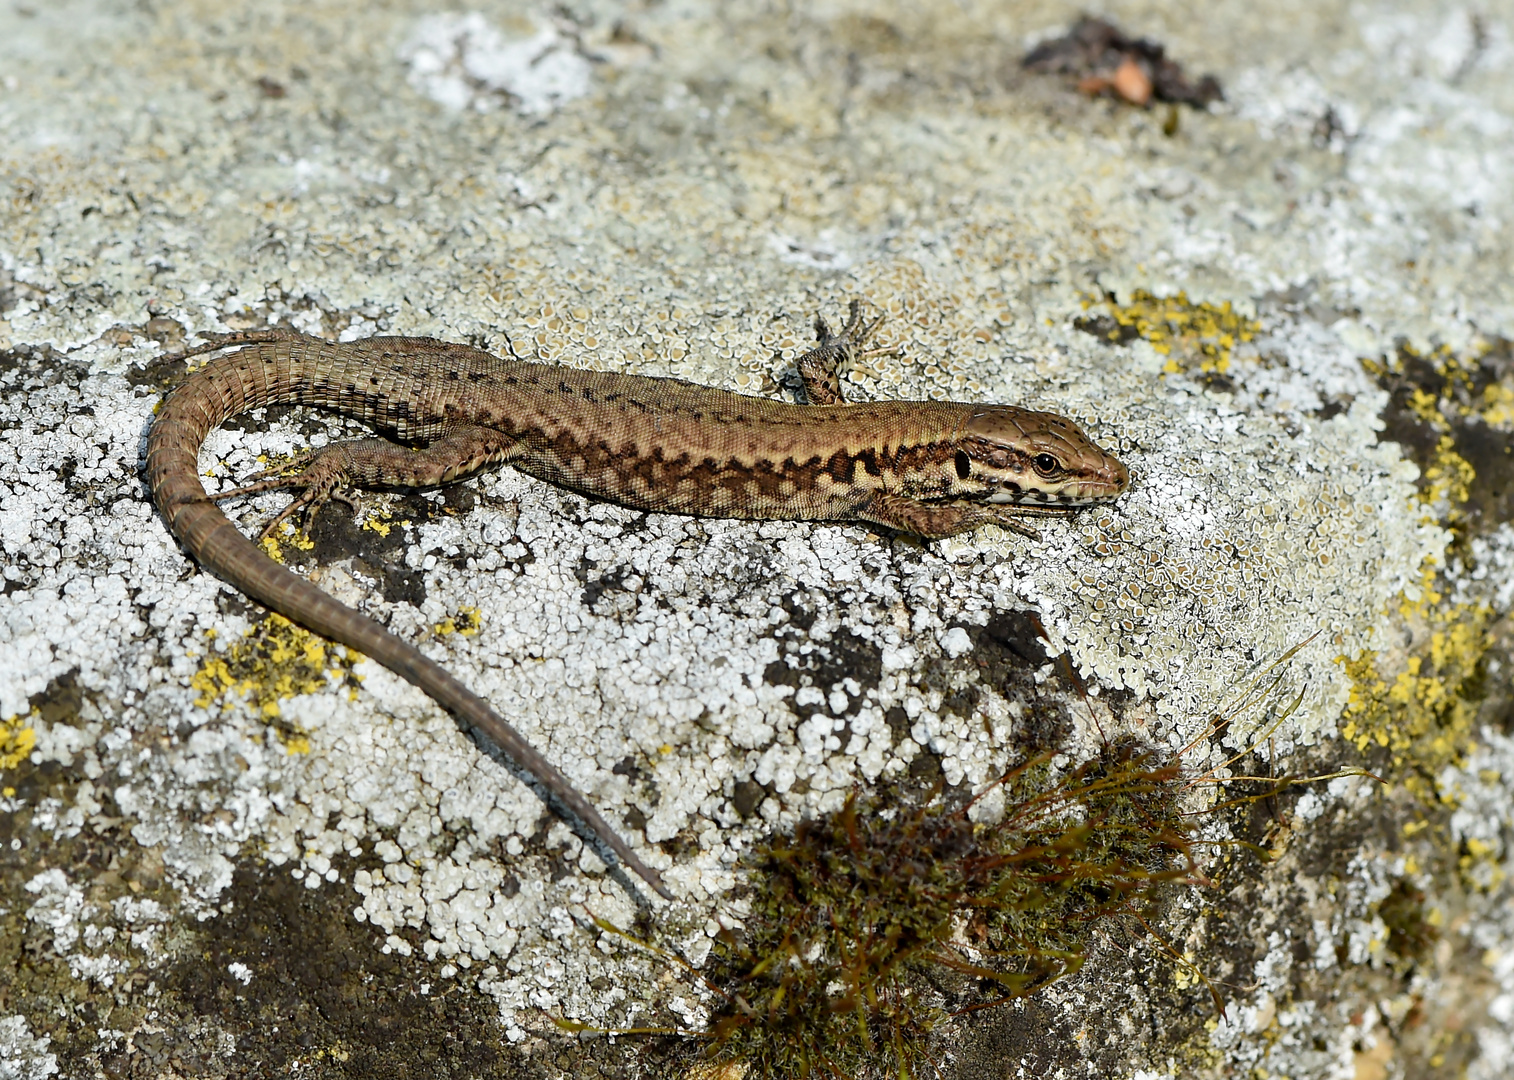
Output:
[{"xmin": 210, "ymin": 424, "xmax": 519, "ymax": 538}]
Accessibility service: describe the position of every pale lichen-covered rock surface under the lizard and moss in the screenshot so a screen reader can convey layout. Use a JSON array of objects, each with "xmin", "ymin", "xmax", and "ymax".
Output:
[{"xmin": 0, "ymin": 0, "xmax": 1514, "ymax": 1077}]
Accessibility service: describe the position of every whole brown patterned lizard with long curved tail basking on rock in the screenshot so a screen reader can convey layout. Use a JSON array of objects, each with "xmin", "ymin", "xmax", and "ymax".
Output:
[{"xmin": 145, "ymin": 300, "xmax": 1129, "ymax": 900}]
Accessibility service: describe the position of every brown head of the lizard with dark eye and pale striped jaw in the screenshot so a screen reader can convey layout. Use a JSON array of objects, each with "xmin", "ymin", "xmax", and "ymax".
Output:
[{"xmin": 952, "ymin": 404, "xmax": 1131, "ymax": 510}]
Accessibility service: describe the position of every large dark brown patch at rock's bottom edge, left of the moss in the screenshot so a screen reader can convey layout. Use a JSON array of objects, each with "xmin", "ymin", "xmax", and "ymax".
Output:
[{"xmin": 158, "ymin": 857, "xmax": 578, "ymax": 1077}]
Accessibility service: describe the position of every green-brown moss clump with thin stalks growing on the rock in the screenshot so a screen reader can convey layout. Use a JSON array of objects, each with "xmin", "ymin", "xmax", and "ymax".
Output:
[{"xmin": 702, "ymin": 745, "xmax": 1193, "ymax": 1078}]
